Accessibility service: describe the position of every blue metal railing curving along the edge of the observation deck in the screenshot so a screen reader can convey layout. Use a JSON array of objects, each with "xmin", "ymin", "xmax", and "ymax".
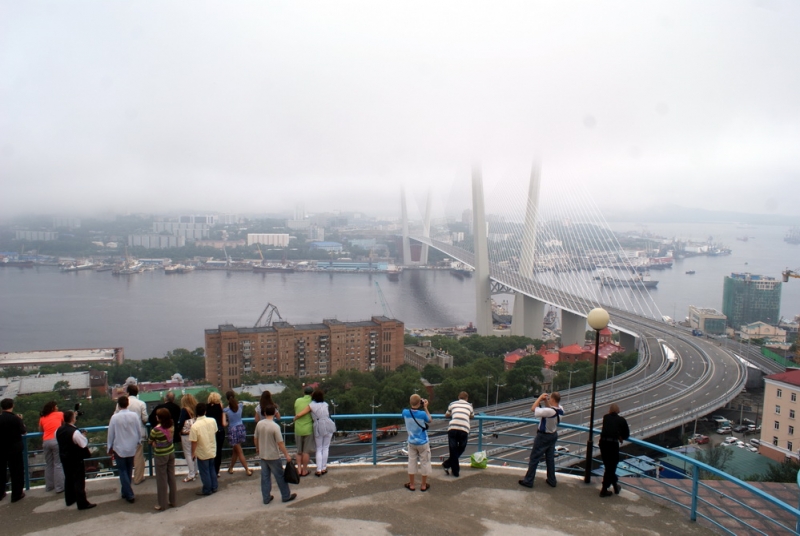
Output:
[{"xmin": 14, "ymin": 414, "xmax": 800, "ymax": 535}]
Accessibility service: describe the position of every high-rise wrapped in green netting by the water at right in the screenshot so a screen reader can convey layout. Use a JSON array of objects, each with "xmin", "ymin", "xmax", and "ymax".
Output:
[{"xmin": 722, "ymin": 273, "xmax": 781, "ymax": 329}]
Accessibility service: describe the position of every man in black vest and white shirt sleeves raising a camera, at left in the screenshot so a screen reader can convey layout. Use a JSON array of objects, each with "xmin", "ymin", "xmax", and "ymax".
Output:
[{"xmin": 56, "ymin": 410, "xmax": 97, "ymax": 510}]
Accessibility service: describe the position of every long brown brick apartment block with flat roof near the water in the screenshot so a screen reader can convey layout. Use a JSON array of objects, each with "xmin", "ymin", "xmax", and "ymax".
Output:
[{"xmin": 205, "ymin": 316, "xmax": 404, "ymax": 390}]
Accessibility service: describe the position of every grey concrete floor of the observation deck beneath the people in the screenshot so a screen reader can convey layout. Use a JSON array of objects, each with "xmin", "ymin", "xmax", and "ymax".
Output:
[{"xmin": 0, "ymin": 464, "xmax": 714, "ymax": 536}]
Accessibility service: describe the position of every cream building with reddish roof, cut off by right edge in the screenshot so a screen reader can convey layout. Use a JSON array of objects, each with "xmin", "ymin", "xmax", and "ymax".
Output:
[{"xmin": 759, "ymin": 369, "xmax": 800, "ymax": 462}]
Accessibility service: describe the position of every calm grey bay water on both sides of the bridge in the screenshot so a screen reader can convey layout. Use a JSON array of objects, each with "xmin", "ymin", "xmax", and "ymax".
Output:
[{"xmin": 0, "ymin": 223, "xmax": 800, "ymax": 359}]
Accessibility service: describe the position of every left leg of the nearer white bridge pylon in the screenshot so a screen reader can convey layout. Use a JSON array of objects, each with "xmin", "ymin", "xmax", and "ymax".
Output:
[{"xmin": 472, "ymin": 166, "xmax": 492, "ymax": 335}]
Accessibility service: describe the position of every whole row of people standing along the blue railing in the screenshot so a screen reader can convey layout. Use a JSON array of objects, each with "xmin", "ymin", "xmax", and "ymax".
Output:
[{"xmin": 0, "ymin": 384, "xmax": 629, "ymax": 511}]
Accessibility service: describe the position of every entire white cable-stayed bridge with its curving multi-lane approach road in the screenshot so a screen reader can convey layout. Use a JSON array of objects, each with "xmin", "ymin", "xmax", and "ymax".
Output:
[{"xmin": 402, "ymin": 167, "xmax": 764, "ymax": 444}]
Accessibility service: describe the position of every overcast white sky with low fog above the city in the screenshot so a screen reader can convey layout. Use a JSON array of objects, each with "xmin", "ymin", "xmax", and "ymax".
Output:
[{"xmin": 0, "ymin": 0, "xmax": 800, "ymax": 217}]
